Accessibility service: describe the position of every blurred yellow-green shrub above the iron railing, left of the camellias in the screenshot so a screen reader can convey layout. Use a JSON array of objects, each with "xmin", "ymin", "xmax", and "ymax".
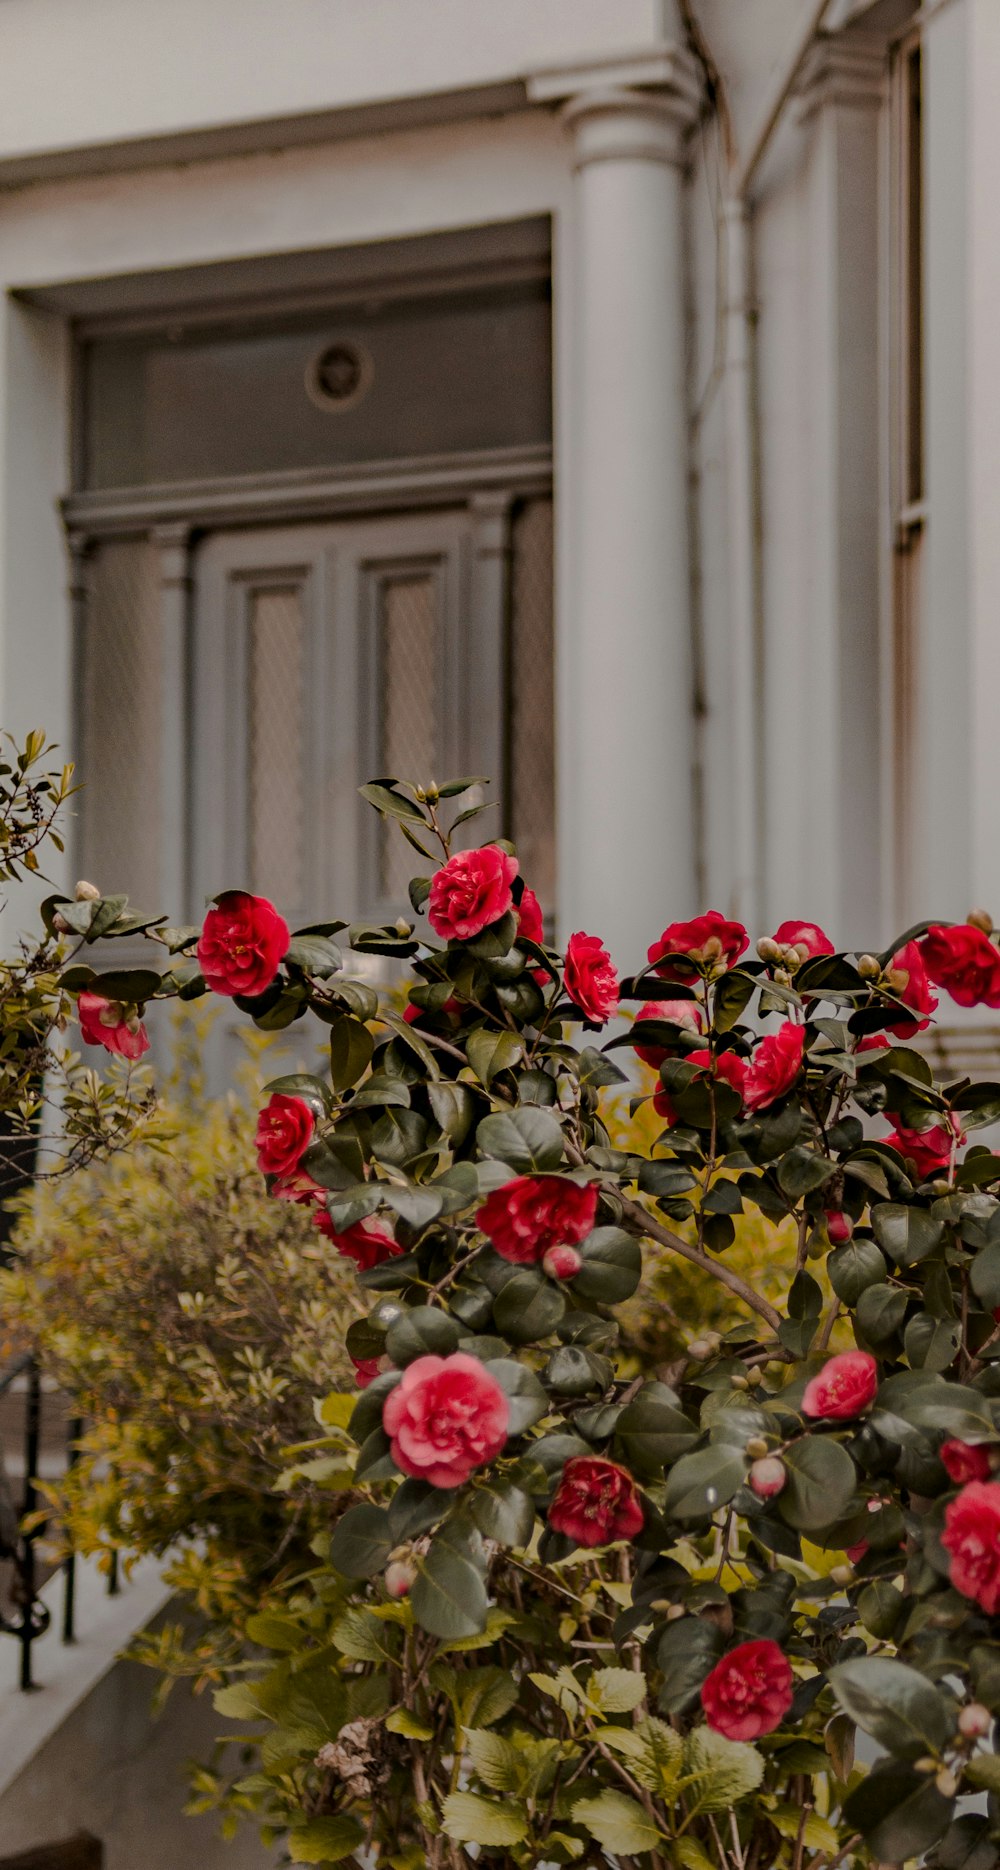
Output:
[{"xmin": 0, "ymin": 1069, "xmax": 368, "ymax": 1608}]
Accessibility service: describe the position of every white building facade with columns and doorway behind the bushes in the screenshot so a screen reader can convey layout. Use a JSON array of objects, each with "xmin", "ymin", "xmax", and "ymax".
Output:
[{"xmin": 0, "ymin": 0, "xmax": 1000, "ymax": 965}]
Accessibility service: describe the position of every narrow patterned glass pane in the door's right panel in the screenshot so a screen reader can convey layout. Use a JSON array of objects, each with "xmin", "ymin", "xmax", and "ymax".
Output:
[{"xmin": 379, "ymin": 574, "xmax": 433, "ymax": 903}]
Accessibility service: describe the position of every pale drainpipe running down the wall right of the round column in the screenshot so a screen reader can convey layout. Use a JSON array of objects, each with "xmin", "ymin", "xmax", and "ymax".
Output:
[{"xmin": 721, "ymin": 0, "xmax": 832, "ymax": 929}]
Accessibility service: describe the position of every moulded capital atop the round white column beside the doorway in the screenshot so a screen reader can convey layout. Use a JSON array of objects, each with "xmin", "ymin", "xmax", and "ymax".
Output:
[{"xmin": 527, "ymin": 43, "xmax": 701, "ymax": 168}]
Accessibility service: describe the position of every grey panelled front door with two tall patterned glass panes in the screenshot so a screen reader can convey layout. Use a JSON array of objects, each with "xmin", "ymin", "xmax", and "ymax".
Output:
[{"xmin": 191, "ymin": 509, "xmax": 493, "ymax": 922}]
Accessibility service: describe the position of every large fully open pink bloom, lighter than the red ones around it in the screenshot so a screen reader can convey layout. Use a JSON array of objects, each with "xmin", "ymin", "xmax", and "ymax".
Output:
[{"xmin": 381, "ymin": 1350, "xmax": 510, "ymax": 1487}]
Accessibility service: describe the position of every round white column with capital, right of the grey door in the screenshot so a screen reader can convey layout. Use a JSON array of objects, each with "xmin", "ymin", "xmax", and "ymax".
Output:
[{"xmin": 536, "ymin": 62, "xmax": 695, "ymax": 969}]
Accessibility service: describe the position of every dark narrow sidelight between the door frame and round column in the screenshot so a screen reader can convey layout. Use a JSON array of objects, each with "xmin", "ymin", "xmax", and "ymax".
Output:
[{"xmin": 510, "ymin": 499, "xmax": 555, "ymax": 911}]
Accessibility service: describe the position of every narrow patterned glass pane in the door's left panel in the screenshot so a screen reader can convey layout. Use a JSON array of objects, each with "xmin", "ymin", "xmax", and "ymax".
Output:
[{"xmin": 249, "ymin": 585, "xmax": 305, "ymax": 913}]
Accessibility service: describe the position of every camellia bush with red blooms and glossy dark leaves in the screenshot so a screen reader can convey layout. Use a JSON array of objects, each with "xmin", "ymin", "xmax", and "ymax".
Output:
[{"xmin": 29, "ymin": 780, "xmax": 1000, "ymax": 1870}]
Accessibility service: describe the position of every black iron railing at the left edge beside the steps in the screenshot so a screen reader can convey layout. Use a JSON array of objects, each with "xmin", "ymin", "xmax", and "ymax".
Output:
[{"xmin": 0, "ymin": 1352, "xmax": 118, "ymax": 1692}]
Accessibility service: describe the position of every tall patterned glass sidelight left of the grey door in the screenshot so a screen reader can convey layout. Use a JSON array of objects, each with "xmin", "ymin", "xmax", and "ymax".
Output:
[{"xmin": 77, "ymin": 539, "xmax": 161, "ymax": 914}]
